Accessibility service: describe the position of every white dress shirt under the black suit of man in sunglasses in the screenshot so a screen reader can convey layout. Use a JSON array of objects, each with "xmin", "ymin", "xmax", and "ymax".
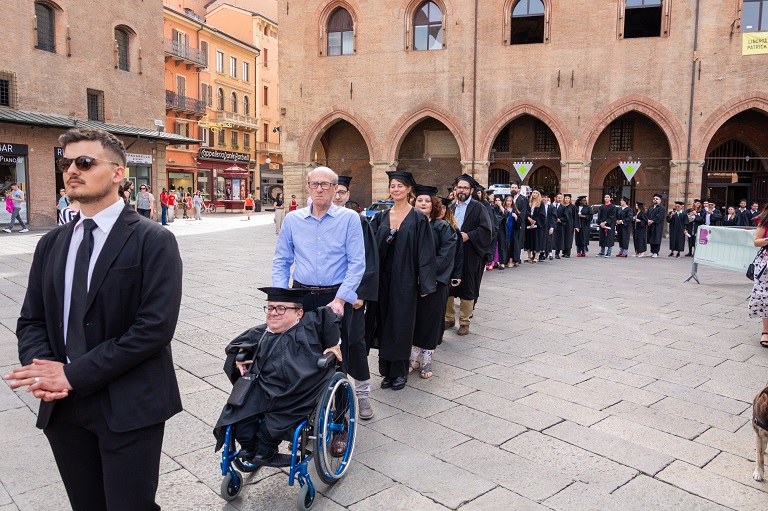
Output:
[{"xmin": 64, "ymin": 197, "xmax": 125, "ymax": 344}]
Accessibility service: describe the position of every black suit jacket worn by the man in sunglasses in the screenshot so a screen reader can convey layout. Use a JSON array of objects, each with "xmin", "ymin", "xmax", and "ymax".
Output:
[{"xmin": 16, "ymin": 206, "xmax": 182, "ymax": 432}]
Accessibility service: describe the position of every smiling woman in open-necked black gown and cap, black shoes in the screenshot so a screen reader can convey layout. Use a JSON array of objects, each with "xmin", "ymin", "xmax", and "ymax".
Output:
[{"xmin": 367, "ymin": 170, "xmax": 437, "ymax": 390}]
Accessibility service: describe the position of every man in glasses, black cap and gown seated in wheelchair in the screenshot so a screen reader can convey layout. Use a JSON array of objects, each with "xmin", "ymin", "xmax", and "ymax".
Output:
[{"xmin": 214, "ymin": 287, "xmax": 341, "ymax": 465}]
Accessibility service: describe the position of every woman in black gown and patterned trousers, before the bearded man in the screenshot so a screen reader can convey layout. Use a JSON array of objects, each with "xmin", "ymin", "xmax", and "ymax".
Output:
[{"xmin": 409, "ymin": 185, "xmax": 458, "ymax": 379}]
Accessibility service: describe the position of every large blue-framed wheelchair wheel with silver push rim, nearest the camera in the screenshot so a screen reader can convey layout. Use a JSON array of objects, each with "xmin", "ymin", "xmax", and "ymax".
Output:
[{"xmin": 314, "ymin": 373, "xmax": 357, "ymax": 484}]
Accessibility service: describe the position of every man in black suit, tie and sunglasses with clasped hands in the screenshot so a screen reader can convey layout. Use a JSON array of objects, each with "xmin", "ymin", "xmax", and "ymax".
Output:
[{"xmin": 5, "ymin": 128, "xmax": 182, "ymax": 511}]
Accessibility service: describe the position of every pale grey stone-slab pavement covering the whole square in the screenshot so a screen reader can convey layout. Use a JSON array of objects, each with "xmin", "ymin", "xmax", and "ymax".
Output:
[{"xmin": 0, "ymin": 213, "xmax": 768, "ymax": 511}]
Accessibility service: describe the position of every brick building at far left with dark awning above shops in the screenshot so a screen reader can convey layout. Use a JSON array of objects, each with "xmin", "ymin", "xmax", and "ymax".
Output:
[{"xmin": 0, "ymin": 0, "xmax": 195, "ymax": 226}]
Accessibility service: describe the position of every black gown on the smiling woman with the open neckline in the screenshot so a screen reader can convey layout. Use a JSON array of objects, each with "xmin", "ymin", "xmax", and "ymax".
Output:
[{"xmin": 366, "ymin": 208, "xmax": 437, "ymax": 362}]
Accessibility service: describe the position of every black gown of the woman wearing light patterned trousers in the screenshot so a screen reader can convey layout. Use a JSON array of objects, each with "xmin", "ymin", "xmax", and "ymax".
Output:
[{"xmin": 413, "ymin": 220, "xmax": 457, "ymax": 350}]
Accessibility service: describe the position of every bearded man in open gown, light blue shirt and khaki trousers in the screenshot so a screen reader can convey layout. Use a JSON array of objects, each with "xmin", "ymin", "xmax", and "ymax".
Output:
[{"xmin": 445, "ymin": 174, "xmax": 492, "ymax": 335}]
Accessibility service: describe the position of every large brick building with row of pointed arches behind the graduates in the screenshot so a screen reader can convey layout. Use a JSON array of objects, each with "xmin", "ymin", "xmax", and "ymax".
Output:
[{"xmin": 279, "ymin": 0, "xmax": 768, "ymax": 212}]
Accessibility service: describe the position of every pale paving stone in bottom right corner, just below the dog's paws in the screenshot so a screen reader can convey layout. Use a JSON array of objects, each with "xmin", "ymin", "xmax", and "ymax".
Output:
[{"xmin": 657, "ymin": 461, "xmax": 766, "ymax": 511}]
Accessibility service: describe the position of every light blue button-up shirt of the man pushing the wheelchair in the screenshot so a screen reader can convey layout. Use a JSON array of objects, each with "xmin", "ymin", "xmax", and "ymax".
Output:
[{"xmin": 272, "ymin": 204, "xmax": 365, "ymax": 303}]
